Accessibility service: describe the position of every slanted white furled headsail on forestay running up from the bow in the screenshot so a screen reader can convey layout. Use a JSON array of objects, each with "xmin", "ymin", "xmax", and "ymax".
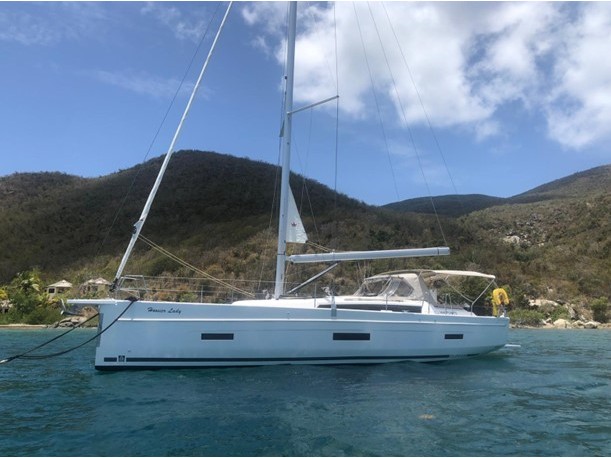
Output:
[{"xmin": 111, "ymin": 2, "xmax": 233, "ymax": 291}]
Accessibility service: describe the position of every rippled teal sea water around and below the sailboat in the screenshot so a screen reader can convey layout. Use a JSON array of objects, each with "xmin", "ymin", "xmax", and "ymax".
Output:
[{"xmin": 0, "ymin": 330, "xmax": 611, "ymax": 456}]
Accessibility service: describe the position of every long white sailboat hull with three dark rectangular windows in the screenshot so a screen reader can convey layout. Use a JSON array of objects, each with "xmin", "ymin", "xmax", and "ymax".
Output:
[{"xmin": 85, "ymin": 299, "xmax": 509, "ymax": 370}]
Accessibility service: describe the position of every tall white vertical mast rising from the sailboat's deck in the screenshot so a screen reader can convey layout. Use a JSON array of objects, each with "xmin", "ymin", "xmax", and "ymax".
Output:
[{"xmin": 274, "ymin": 1, "xmax": 297, "ymax": 299}]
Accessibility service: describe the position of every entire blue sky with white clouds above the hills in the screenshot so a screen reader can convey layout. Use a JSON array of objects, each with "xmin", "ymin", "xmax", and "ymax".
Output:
[{"xmin": 0, "ymin": 2, "xmax": 611, "ymax": 205}]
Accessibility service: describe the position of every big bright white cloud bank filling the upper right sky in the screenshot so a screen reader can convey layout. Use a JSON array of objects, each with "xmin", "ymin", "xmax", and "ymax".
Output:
[{"xmin": 242, "ymin": 2, "xmax": 611, "ymax": 152}]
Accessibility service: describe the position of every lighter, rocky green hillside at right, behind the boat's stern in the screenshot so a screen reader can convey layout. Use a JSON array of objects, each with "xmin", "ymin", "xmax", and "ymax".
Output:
[{"xmin": 387, "ymin": 165, "xmax": 611, "ymax": 302}]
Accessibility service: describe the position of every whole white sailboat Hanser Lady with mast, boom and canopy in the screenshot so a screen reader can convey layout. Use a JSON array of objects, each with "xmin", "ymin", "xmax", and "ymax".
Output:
[{"xmin": 69, "ymin": 2, "xmax": 509, "ymax": 370}]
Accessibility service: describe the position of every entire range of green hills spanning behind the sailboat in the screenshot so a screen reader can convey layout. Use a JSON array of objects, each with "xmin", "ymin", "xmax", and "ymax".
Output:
[{"xmin": 0, "ymin": 151, "xmax": 611, "ymax": 308}]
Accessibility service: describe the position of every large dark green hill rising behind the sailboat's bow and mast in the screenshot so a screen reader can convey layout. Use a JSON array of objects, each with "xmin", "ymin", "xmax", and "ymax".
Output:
[{"xmin": 0, "ymin": 151, "xmax": 450, "ymax": 292}]
